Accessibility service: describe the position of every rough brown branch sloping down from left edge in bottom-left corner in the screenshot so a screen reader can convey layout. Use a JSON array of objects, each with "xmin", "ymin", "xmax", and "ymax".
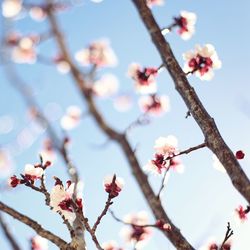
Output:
[{"xmin": 0, "ymin": 201, "xmax": 72, "ymax": 250}]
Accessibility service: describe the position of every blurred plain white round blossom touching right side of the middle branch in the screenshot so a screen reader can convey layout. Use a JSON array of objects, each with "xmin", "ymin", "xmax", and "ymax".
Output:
[{"xmin": 92, "ymin": 74, "xmax": 119, "ymax": 98}]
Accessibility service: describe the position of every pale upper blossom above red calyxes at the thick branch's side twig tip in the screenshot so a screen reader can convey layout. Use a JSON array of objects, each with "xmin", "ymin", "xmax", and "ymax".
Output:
[{"xmin": 154, "ymin": 135, "xmax": 178, "ymax": 157}]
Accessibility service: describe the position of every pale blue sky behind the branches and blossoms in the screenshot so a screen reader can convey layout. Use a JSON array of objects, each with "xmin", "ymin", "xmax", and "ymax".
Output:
[{"xmin": 0, "ymin": 0, "xmax": 250, "ymax": 250}]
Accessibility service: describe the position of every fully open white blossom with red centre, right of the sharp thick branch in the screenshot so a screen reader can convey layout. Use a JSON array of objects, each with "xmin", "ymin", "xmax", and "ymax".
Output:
[{"xmin": 183, "ymin": 44, "xmax": 221, "ymax": 80}]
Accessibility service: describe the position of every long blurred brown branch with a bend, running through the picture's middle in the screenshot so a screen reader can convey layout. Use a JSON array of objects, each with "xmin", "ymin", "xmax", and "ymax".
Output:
[{"xmin": 47, "ymin": 0, "xmax": 193, "ymax": 250}]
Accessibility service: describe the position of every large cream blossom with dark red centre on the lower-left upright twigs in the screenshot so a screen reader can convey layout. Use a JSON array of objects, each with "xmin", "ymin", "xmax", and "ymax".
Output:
[{"xmin": 50, "ymin": 178, "xmax": 79, "ymax": 222}]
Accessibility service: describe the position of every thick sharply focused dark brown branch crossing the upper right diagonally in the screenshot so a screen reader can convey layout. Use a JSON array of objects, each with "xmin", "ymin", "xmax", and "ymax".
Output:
[{"xmin": 133, "ymin": 0, "xmax": 250, "ymax": 203}]
